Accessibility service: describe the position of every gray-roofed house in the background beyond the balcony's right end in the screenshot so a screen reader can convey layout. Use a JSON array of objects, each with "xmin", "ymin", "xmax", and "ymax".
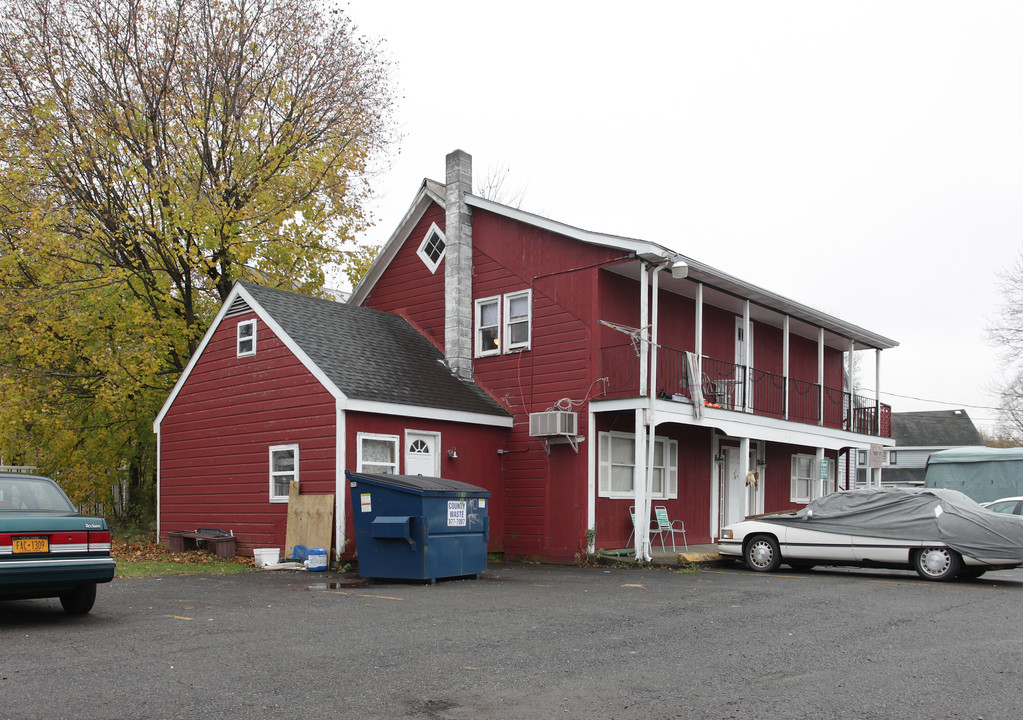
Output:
[{"xmin": 855, "ymin": 410, "xmax": 984, "ymax": 487}]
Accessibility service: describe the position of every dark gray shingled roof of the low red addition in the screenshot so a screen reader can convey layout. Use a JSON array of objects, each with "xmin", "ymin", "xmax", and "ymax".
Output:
[{"xmin": 240, "ymin": 281, "xmax": 510, "ymax": 417}]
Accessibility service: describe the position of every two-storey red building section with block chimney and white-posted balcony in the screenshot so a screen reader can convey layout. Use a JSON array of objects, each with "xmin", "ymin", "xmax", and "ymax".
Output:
[{"xmin": 351, "ymin": 150, "xmax": 896, "ymax": 560}]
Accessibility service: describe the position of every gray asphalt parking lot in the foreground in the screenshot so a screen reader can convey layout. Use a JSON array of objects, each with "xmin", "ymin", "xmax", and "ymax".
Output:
[{"xmin": 0, "ymin": 564, "xmax": 1023, "ymax": 720}]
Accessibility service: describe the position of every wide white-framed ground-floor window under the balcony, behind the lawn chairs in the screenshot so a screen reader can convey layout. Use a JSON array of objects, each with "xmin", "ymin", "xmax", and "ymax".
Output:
[{"xmin": 597, "ymin": 433, "xmax": 678, "ymax": 500}]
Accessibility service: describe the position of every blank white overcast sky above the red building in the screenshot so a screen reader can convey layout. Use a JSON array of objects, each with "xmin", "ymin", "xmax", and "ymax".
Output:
[{"xmin": 347, "ymin": 0, "xmax": 1023, "ymax": 425}]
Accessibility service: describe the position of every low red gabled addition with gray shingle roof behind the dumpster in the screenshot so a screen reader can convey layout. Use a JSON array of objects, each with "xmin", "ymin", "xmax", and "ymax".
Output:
[{"xmin": 153, "ymin": 282, "xmax": 512, "ymax": 551}]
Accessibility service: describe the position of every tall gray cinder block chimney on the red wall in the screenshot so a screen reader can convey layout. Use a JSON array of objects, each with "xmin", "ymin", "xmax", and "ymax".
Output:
[{"xmin": 444, "ymin": 150, "xmax": 473, "ymax": 379}]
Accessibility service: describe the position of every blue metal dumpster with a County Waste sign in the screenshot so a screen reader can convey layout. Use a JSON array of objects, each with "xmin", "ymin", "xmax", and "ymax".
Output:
[{"xmin": 345, "ymin": 470, "xmax": 490, "ymax": 583}]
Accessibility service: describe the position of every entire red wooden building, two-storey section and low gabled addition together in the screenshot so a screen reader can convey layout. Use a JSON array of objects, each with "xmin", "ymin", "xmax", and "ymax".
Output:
[{"xmin": 157, "ymin": 151, "xmax": 896, "ymax": 560}]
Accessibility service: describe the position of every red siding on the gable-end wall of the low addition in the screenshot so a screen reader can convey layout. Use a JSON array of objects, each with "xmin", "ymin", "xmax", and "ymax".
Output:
[{"xmin": 160, "ymin": 314, "xmax": 336, "ymax": 548}]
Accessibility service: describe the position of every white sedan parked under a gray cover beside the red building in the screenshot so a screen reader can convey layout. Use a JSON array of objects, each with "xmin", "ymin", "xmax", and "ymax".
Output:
[{"xmin": 717, "ymin": 488, "xmax": 1023, "ymax": 580}]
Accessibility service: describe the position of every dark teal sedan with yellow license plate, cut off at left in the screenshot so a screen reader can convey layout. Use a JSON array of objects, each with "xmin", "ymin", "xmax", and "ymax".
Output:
[{"xmin": 0, "ymin": 473, "xmax": 117, "ymax": 615}]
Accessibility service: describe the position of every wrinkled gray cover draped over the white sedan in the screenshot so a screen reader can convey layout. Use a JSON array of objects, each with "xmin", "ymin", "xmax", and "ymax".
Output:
[{"xmin": 757, "ymin": 488, "xmax": 1023, "ymax": 565}]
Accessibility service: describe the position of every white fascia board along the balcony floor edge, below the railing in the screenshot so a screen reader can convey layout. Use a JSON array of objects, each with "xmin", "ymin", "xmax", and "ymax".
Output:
[{"xmin": 590, "ymin": 398, "xmax": 895, "ymax": 450}]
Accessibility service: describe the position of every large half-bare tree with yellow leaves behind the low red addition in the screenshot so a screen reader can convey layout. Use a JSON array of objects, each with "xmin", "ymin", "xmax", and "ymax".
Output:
[{"xmin": 0, "ymin": 0, "xmax": 392, "ymax": 517}]
